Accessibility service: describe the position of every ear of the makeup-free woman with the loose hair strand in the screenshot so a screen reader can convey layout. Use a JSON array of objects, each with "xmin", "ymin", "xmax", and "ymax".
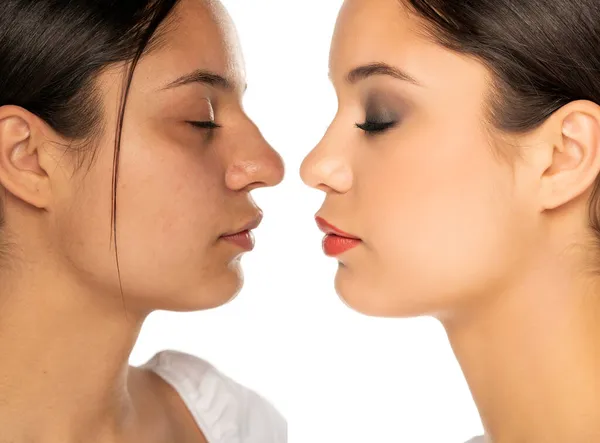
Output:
[{"xmin": 0, "ymin": 106, "xmax": 51, "ymax": 209}]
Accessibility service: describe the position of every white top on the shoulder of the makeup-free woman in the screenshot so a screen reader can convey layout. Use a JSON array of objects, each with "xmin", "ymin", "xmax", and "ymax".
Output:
[{"xmin": 143, "ymin": 351, "xmax": 287, "ymax": 443}]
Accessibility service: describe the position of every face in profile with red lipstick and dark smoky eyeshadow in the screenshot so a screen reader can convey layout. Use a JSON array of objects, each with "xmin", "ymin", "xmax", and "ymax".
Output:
[{"xmin": 301, "ymin": 0, "xmax": 532, "ymax": 316}]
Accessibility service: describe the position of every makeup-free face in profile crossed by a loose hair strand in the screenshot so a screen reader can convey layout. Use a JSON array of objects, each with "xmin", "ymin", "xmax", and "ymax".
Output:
[{"xmin": 52, "ymin": 0, "xmax": 283, "ymax": 310}]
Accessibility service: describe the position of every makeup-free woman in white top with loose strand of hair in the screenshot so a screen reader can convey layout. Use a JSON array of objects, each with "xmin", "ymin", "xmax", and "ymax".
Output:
[{"xmin": 0, "ymin": 0, "xmax": 287, "ymax": 443}]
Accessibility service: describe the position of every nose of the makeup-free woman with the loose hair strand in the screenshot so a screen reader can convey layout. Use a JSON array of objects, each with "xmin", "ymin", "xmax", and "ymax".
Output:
[{"xmin": 225, "ymin": 122, "xmax": 285, "ymax": 191}]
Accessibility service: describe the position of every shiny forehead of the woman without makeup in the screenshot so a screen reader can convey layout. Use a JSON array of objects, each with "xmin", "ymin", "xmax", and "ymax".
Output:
[{"xmin": 139, "ymin": 0, "xmax": 245, "ymax": 88}]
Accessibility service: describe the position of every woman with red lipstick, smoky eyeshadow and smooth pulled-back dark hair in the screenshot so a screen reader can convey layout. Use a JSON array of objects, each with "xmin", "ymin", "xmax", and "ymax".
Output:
[{"xmin": 301, "ymin": 0, "xmax": 600, "ymax": 443}]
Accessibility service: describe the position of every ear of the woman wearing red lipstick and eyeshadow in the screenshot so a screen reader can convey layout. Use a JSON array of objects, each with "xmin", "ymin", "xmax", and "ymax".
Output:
[{"xmin": 537, "ymin": 100, "xmax": 600, "ymax": 209}]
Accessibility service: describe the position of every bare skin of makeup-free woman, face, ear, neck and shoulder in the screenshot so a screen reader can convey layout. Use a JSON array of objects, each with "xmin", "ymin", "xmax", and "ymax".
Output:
[{"xmin": 0, "ymin": 0, "xmax": 284, "ymax": 443}]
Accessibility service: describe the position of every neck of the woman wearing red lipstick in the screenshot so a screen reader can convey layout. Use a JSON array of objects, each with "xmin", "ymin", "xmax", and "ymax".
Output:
[{"xmin": 443, "ymin": 256, "xmax": 600, "ymax": 443}]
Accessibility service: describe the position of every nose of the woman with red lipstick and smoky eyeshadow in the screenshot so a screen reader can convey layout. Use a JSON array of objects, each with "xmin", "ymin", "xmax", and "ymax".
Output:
[{"xmin": 300, "ymin": 126, "xmax": 353, "ymax": 194}]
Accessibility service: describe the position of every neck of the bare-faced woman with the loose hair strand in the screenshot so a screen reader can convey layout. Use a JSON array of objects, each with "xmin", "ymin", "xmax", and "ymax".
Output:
[{"xmin": 0, "ymin": 260, "xmax": 158, "ymax": 442}]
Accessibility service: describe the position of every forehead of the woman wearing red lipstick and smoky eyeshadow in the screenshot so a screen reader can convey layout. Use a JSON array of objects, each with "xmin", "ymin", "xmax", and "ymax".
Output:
[{"xmin": 329, "ymin": 0, "xmax": 489, "ymax": 95}]
